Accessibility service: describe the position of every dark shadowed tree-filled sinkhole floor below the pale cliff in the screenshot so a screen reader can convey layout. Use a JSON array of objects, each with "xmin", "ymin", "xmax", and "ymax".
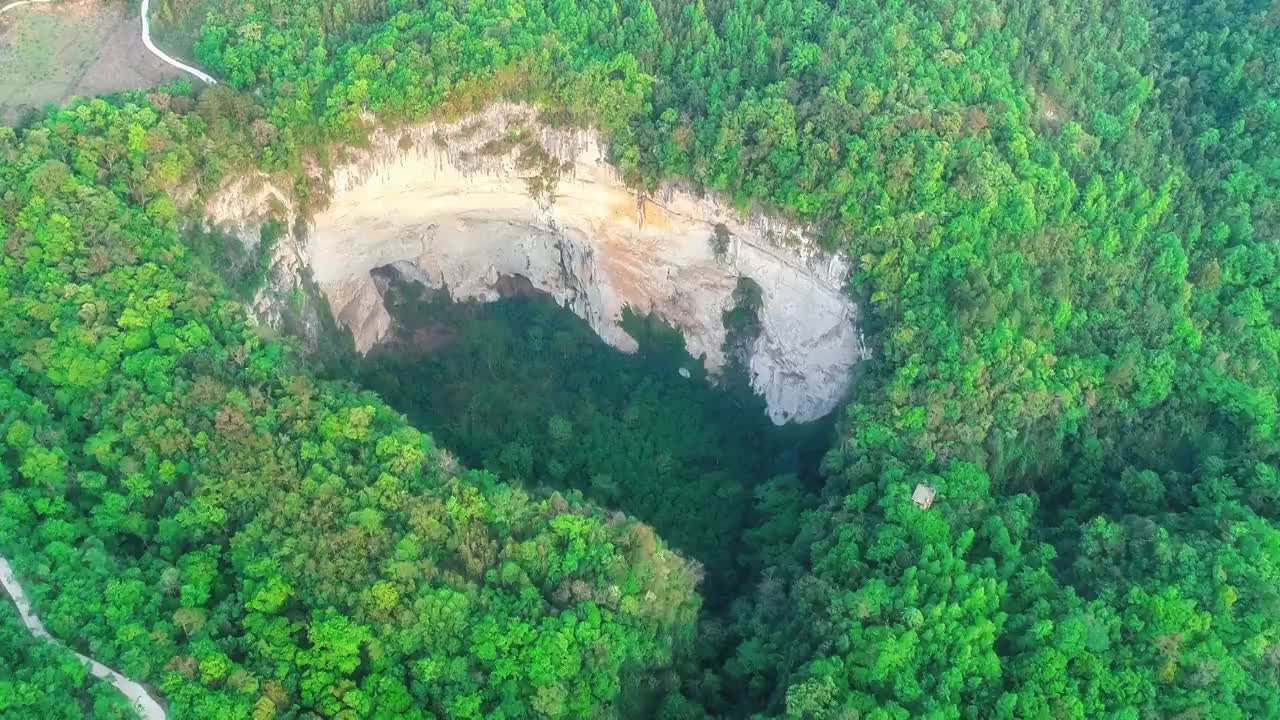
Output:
[{"xmin": 344, "ymin": 266, "xmax": 832, "ymax": 599}]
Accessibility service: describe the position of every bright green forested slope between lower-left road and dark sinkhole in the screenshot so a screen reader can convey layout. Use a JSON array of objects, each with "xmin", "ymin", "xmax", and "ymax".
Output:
[{"xmin": 0, "ymin": 100, "xmax": 699, "ymax": 719}]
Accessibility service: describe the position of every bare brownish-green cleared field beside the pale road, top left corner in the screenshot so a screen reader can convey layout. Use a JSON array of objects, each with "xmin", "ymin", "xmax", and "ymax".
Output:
[{"xmin": 0, "ymin": 0, "xmax": 179, "ymax": 126}]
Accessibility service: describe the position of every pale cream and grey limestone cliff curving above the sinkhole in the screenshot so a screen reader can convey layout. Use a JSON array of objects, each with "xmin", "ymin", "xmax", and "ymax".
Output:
[{"xmin": 209, "ymin": 105, "xmax": 867, "ymax": 423}]
